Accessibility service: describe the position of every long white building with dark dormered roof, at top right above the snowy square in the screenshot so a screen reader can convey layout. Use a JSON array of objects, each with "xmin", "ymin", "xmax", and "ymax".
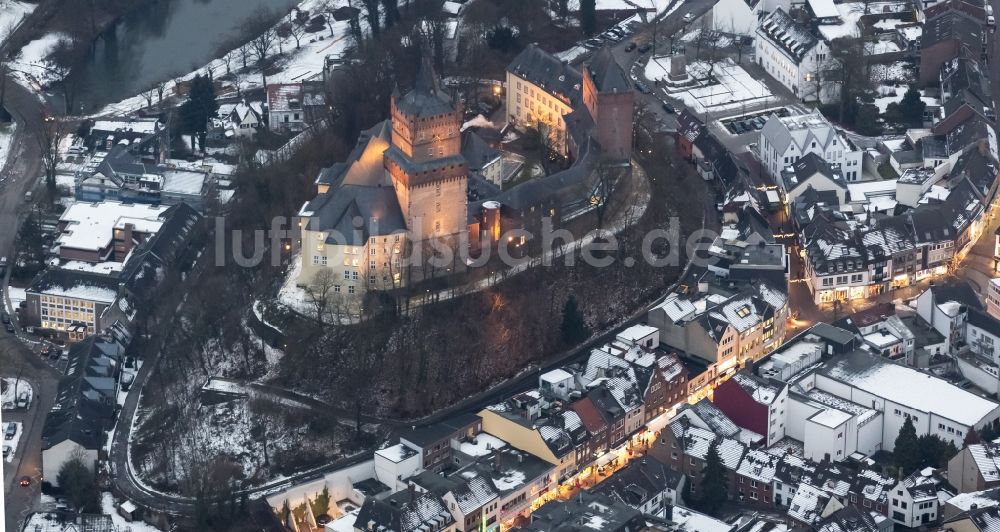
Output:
[{"xmin": 754, "ymin": 7, "xmax": 838, "ymax": 103}]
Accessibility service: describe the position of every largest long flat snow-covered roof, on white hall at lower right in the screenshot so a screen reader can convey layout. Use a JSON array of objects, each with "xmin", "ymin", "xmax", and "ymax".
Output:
[{"xmin": 820, "ymin": 352, "xmax": 1000, "ymax": 426}]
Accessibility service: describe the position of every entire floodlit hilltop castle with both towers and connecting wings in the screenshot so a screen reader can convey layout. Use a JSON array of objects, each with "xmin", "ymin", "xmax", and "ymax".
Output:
[{"xmin": 298, "ymin": 49, "xmax": 633, "ymax": 304}]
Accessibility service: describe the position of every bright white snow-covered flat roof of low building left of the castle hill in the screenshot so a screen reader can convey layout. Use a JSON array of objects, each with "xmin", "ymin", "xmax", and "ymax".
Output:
[{"xmin": 56, "ymin": 201, "xmax": 168, "ymax": 255}]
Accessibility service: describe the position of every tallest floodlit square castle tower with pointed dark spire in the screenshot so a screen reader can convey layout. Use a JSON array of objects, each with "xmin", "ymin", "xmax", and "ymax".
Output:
[{"xmin": 384, "ymin": 58, "xmax": 468, "ymax": 242}]
